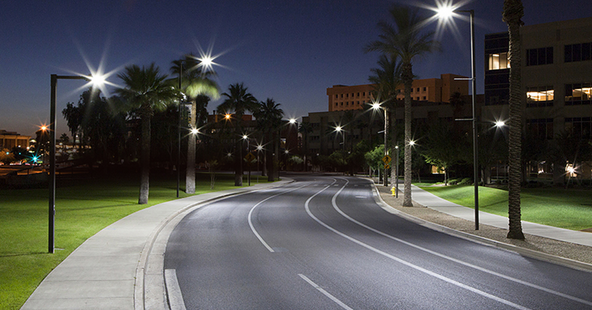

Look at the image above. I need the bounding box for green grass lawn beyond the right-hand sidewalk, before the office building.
[422,186,592,230]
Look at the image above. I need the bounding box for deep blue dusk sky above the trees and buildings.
[0,0,592,136]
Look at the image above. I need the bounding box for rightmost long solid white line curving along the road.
[331,180,592,306]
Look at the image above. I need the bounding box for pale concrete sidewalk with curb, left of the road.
[21,178,293,310]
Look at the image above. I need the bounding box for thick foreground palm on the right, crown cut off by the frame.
[502,0,524,240]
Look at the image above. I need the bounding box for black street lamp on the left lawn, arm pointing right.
[48,74,105,253]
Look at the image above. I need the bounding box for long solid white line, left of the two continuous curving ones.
[304,180,529,310]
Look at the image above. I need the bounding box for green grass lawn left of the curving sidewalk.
[0,174,267,309]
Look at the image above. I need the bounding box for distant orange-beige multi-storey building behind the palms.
[327,74,469,112]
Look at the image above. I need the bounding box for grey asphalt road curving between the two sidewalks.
[165,176,592,309]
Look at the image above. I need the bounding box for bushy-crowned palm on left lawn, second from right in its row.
[218,83,259,186]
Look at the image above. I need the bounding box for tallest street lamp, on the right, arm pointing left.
[437,5,479,230]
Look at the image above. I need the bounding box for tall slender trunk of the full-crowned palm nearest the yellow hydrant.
[402,63,413,207]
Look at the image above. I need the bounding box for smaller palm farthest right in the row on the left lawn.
[254,98,284,182]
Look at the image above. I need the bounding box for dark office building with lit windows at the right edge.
[481,18,592,182]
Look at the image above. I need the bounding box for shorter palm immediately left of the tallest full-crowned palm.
[368,54,401,186]
